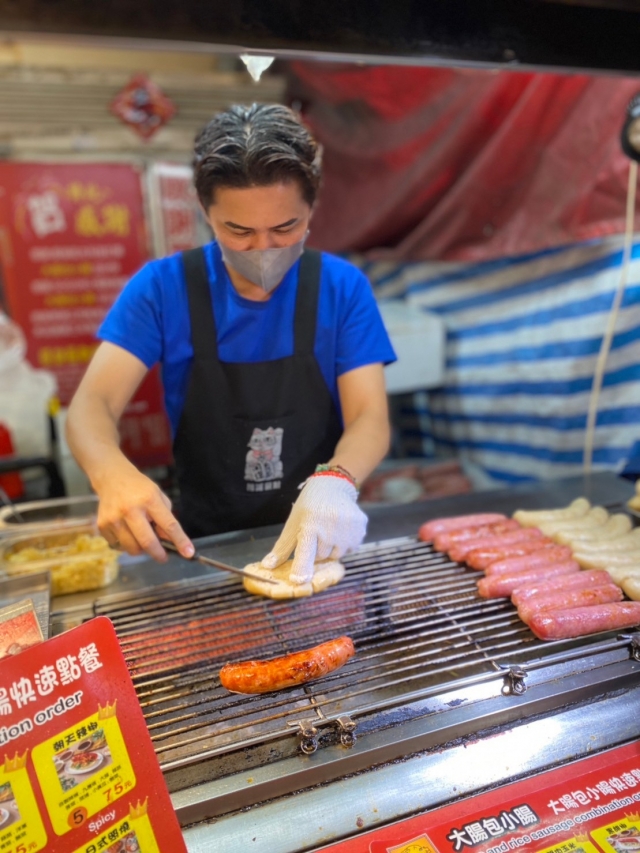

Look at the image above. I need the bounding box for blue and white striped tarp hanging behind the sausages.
[362,237,640,484]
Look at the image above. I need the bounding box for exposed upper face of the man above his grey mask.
[207,181,311,252]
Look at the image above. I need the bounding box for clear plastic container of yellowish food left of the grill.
[0,525,119,595]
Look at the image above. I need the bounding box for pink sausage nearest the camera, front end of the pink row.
[529,601,640,640]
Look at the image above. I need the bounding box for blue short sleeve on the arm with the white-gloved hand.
[336,268,396,376]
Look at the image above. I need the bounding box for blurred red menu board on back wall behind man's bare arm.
[0,162,171,465]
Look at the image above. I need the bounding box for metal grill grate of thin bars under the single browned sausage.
[95,538,608,770]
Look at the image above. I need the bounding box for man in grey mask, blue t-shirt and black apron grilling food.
[67,104,395,583]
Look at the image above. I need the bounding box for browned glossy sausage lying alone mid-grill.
[220,637,356,693]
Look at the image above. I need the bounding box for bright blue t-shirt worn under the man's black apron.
[98,242,396,436]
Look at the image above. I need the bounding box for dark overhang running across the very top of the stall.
[0,0,640,73]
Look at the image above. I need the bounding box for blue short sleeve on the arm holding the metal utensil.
[97,261,163,369]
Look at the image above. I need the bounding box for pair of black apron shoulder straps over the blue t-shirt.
[182,247,322,360]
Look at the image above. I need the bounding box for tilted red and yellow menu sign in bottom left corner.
[0,617,186,853]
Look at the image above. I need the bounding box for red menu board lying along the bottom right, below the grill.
[322,741,640,853]
